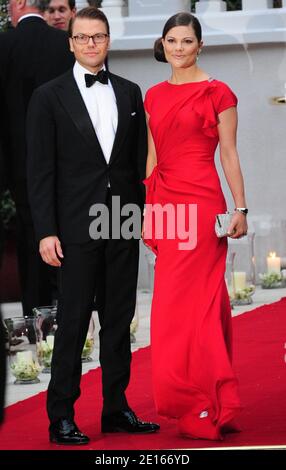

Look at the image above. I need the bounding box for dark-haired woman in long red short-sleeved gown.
[143,13,247,439]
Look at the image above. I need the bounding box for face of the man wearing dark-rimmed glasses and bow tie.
[70,18,110,73]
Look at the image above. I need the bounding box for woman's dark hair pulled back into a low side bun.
[154,12,202,62]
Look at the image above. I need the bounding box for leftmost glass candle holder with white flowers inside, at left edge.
[5,317,42,385]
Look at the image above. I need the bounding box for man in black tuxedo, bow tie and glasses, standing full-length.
[27,7,159,444]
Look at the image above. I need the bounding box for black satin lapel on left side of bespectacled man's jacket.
[54,70,106,164]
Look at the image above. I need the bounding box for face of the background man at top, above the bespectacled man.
[45,0,76,31]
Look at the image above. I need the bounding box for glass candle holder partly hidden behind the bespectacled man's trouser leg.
[33,306,57,374]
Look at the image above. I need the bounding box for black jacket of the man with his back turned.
[0,16,74,203]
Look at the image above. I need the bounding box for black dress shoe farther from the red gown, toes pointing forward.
[49,418,89,445]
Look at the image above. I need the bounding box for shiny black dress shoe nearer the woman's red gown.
[101,410,160,434]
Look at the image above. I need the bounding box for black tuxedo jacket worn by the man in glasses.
[27,70,147,243]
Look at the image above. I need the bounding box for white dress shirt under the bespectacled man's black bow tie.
[73,62,118,163]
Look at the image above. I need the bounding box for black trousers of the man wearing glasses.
[47,192,139,422]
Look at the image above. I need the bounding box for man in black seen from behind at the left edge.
[0,0,74,315]
